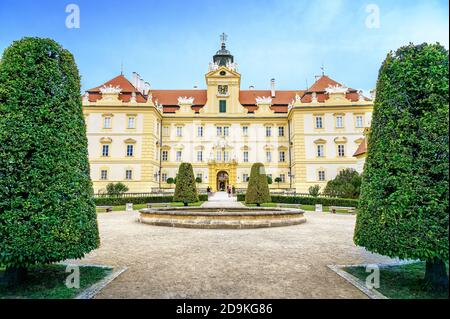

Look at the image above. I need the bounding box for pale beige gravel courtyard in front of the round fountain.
[68,212,392,298]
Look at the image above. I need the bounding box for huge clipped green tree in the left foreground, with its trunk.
[0,38,99,284]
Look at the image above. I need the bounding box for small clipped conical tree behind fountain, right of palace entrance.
[245,163,272,206]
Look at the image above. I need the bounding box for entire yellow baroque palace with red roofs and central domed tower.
[83,37,373,192]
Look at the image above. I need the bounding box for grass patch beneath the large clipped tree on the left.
[0,264,112,299]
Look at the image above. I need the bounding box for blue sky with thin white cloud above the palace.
[0,0,449,91]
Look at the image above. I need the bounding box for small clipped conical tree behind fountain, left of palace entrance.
[173,163,198,206]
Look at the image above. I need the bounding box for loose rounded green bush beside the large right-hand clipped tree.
[323,168,361,198]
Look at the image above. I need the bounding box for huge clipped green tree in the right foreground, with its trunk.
[354,44,449,290]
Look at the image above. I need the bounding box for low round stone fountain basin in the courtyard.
[139,207,306,229]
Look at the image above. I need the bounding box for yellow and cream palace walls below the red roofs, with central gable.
[83,67,373,193]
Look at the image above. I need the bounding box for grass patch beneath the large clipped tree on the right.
[344,262,448,299]
